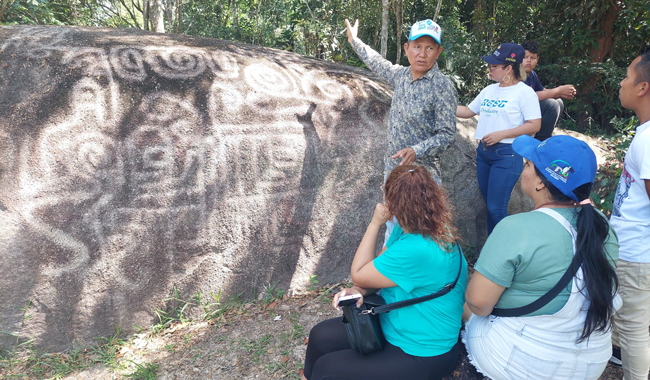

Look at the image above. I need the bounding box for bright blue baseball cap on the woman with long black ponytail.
[512,135,598,202]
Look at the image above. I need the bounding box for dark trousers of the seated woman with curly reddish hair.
[304,318,460,380]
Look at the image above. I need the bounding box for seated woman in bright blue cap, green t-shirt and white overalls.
[463,136,621,379]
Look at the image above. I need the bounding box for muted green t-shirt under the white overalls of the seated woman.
[474,208,618,315]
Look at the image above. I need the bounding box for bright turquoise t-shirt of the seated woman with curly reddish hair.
[374,225,467,356]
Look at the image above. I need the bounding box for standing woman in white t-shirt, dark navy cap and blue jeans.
[456,43,542,234]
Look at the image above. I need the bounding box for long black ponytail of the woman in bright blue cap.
[535,168,618,342]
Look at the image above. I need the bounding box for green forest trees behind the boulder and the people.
[0,0,650,212]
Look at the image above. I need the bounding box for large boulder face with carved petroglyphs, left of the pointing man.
[0,27,390,349]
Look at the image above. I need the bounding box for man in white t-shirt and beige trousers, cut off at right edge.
[610,46,650,380]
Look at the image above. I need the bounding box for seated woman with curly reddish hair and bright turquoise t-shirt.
[304,165,467,380]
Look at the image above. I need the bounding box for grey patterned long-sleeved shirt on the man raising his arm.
[352,38,458,178]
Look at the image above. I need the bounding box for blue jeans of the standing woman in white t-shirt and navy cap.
[476,143,524,235]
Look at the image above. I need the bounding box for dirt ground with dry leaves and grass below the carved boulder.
[0,283,623,380]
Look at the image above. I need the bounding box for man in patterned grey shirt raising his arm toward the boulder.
[345,20,458,181]
